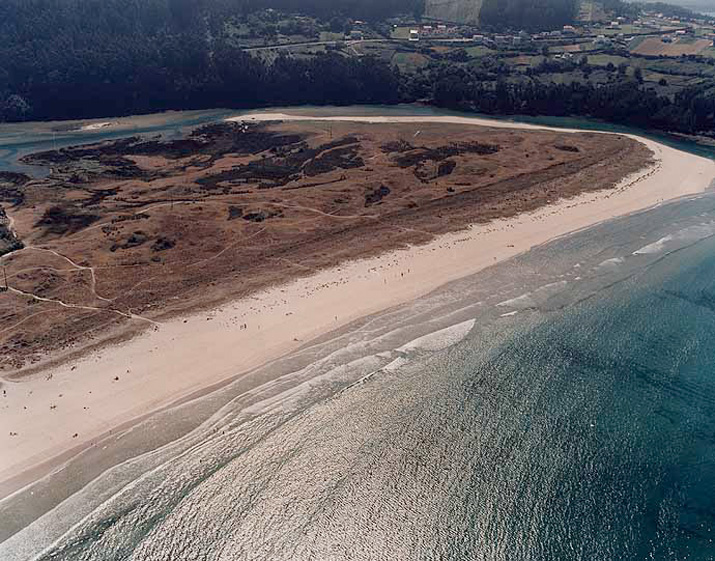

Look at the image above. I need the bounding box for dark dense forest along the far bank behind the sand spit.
[0,0,715,133]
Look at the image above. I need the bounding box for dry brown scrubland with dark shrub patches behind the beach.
[0,123,651,371]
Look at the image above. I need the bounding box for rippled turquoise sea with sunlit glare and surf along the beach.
[0,107,715,561]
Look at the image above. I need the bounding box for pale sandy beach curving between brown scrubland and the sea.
[0,114,715,497]
